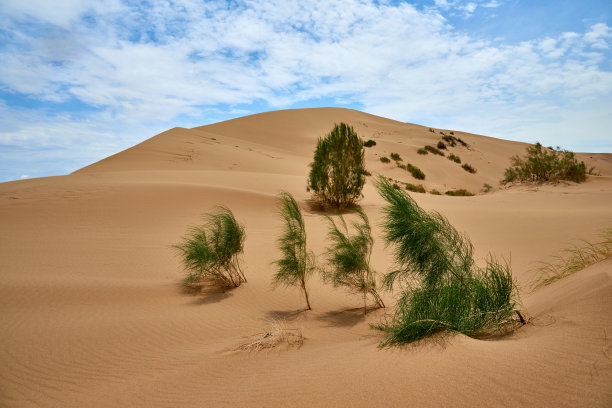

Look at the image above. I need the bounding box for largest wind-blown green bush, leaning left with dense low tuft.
[374,178,515,346]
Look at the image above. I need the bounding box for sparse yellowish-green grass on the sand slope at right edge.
[532,228,612,290]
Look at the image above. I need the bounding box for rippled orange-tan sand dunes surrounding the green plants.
[0,108,612,407]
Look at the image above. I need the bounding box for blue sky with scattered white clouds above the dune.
[0,0,612,181]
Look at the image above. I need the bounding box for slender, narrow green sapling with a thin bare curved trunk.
[273,192,315,310]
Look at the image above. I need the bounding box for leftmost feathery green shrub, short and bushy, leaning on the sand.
[173,207,247,289]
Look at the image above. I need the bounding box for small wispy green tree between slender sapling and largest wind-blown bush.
[322,210,385,314]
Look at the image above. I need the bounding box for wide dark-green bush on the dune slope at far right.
[501,143,586,184]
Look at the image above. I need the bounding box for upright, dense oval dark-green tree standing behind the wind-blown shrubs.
[307,123,365,208]
